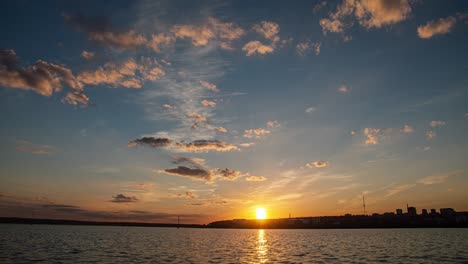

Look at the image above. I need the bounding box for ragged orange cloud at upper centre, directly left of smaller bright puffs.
[171,17,245,50]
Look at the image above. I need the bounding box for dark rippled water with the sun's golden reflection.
[0,224,468,263]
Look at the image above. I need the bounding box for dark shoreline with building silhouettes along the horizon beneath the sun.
[0,207,468,229]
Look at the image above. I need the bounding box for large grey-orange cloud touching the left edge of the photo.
[0,49,83,96]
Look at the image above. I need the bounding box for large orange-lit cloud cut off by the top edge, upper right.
[320,0,411,33]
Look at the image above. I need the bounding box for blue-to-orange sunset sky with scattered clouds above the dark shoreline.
[0,0,468,224]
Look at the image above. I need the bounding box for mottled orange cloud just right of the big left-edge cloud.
[77,58,165,89]
